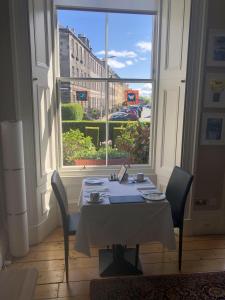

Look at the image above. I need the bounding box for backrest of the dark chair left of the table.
[51,170,68,231]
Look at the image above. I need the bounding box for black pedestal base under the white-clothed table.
[99,245,143,277]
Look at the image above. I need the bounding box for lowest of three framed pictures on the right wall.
[201,113,225,145]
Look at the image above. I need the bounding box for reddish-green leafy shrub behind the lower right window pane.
[116,122,150,163]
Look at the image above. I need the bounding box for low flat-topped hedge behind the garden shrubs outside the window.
[62,121,150,142]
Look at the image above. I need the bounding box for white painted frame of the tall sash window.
[53,0,160,177]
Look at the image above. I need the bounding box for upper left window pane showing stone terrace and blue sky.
[57,9,105,77]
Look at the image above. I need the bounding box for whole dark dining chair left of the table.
[51,171,80,282]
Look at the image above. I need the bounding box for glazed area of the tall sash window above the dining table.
[58,9,154,167]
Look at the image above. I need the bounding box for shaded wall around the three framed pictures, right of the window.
[192,0,225,234]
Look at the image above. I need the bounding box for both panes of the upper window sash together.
[58,9,154,79]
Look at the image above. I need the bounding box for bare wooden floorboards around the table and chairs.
[10,228,225,300]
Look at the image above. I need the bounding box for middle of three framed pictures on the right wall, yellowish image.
[204,73,225,108]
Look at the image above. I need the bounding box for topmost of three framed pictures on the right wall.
[207,29,225,67]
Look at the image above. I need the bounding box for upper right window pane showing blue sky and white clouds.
[108,13,154,79]
